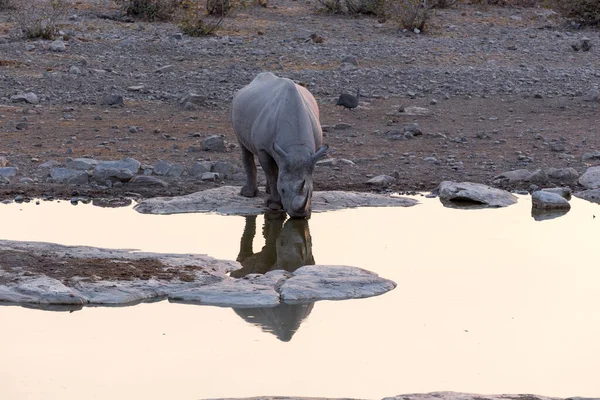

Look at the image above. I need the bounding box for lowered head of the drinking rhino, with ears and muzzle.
[273,143,329,218]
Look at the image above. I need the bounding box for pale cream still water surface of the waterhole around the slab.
[0,197,600,400]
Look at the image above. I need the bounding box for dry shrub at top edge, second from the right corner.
[379,0,436,31]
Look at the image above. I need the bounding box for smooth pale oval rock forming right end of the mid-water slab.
[280,265,396,304]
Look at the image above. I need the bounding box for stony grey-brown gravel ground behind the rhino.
[0,0,600,198]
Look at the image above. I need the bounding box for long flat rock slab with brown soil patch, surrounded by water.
[0,240,396,309]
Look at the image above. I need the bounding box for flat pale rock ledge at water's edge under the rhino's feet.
[134,186,418,215]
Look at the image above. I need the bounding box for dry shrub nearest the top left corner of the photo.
[11,0,71,40]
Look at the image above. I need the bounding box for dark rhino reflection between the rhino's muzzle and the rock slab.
[231,213,315,278]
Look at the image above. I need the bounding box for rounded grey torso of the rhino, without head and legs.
[232,73,322,154]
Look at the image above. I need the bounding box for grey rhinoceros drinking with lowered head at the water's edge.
[231,72,328,218]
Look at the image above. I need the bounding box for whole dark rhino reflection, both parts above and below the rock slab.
[231,213,315,342]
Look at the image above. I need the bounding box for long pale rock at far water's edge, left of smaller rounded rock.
[437,181,517,207]
